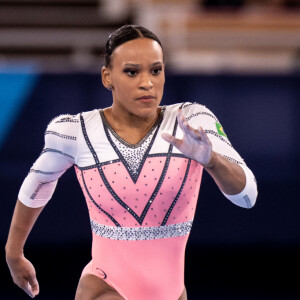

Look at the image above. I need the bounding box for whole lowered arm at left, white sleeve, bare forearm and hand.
[5,115,79,298]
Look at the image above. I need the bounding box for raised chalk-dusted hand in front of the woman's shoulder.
[162,109,212,166]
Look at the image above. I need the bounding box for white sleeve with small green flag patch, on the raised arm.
[182,103,257,208]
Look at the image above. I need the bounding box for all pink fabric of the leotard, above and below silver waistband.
[76,156,203,300]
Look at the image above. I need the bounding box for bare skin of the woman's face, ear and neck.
[102,38,165,144]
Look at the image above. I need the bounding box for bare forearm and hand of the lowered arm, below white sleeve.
[5,199,44,298]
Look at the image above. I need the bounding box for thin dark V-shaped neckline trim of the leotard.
[99,106,165,149]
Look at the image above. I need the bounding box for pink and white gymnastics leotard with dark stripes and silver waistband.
[19,103,257,300]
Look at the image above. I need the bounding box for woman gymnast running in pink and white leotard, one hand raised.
[6,25,257,300]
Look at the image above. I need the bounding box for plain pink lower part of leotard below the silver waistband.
[82,234,188,300]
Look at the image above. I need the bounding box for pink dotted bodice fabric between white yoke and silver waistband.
[76,157,202,227]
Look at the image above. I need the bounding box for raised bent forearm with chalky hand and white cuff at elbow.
[162,110,257,208]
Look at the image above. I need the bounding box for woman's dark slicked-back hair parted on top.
[104,25,163,67]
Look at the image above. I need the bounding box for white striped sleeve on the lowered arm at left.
[18,115,79,207]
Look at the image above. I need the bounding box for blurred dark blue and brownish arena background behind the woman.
[0,0,300,300]
